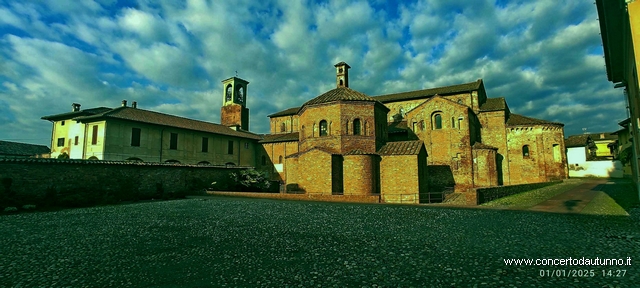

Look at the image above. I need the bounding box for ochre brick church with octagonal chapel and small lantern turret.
[258,62,567,203]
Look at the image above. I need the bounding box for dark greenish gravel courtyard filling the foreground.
[0,197,640,287]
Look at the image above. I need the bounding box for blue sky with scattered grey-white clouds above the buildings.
[0,0,627,146]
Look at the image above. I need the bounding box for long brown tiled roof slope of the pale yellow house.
[74,107,261,140]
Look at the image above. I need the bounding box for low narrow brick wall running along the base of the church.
[207,191,380,203]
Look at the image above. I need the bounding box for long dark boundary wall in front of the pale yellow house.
[0,159,246,204]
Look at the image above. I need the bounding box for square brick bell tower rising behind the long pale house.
[220,77,249,131]
